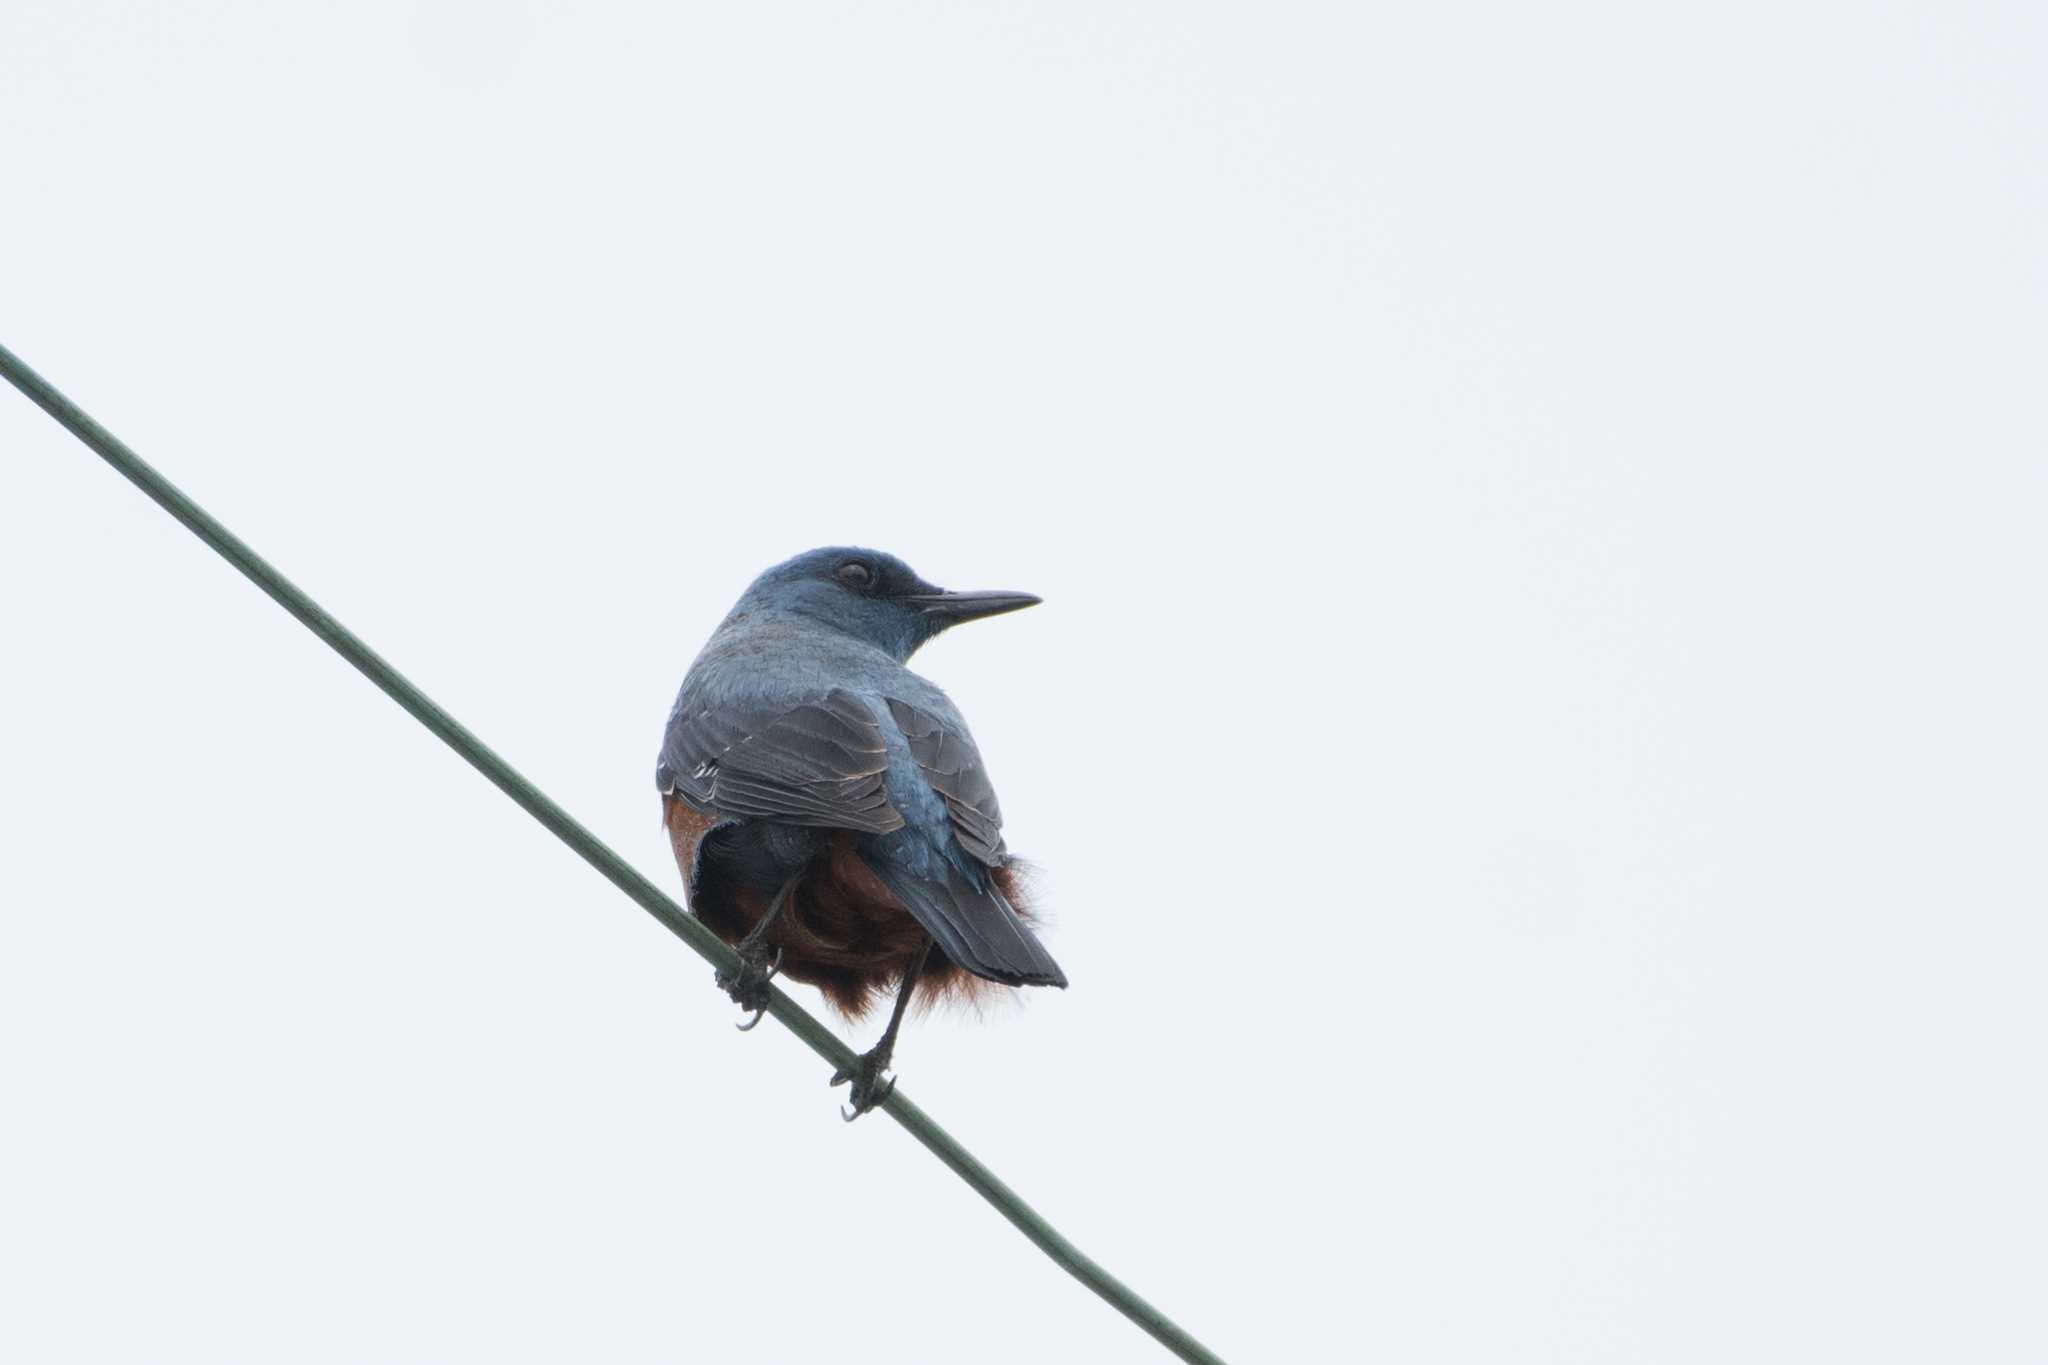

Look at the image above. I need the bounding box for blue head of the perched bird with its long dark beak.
[735,544,1038,663]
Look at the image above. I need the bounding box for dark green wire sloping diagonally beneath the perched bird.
[0,346,1223,1365]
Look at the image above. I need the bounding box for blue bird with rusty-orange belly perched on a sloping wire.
[655,546,1067,1121]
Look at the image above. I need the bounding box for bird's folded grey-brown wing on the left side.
[655,688,903,835]
